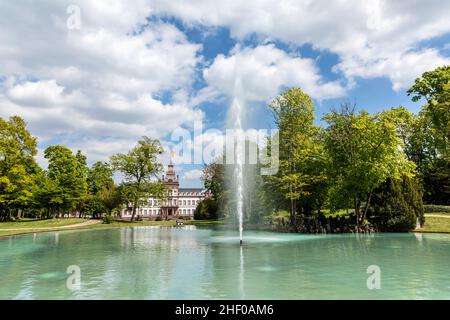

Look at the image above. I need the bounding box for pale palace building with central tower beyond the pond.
[122,162,209,218]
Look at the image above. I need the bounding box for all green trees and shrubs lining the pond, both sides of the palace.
[0,66,450,233]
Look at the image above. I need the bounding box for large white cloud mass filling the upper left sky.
[0,0,203,164]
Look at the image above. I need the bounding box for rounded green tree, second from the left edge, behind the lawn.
[44,146,87,216]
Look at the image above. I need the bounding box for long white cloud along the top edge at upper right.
[153,0,450,90]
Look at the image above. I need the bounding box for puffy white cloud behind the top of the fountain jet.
[204,44,345,101]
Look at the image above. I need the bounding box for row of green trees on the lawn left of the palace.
[0,116,164,221]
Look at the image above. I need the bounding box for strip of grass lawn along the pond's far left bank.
[0,218,223,236]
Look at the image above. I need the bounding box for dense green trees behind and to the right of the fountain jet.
[204,66,450,230]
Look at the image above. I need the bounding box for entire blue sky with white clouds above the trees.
[0,0,450,187]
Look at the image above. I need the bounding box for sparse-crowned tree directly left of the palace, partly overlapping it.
[111,137,164,221]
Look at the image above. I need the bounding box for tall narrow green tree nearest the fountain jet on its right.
[266,89,325,225]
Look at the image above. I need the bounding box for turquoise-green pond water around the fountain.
[0,226,450,299]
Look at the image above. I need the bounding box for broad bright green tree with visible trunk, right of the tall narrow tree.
[324,105,414,227]
